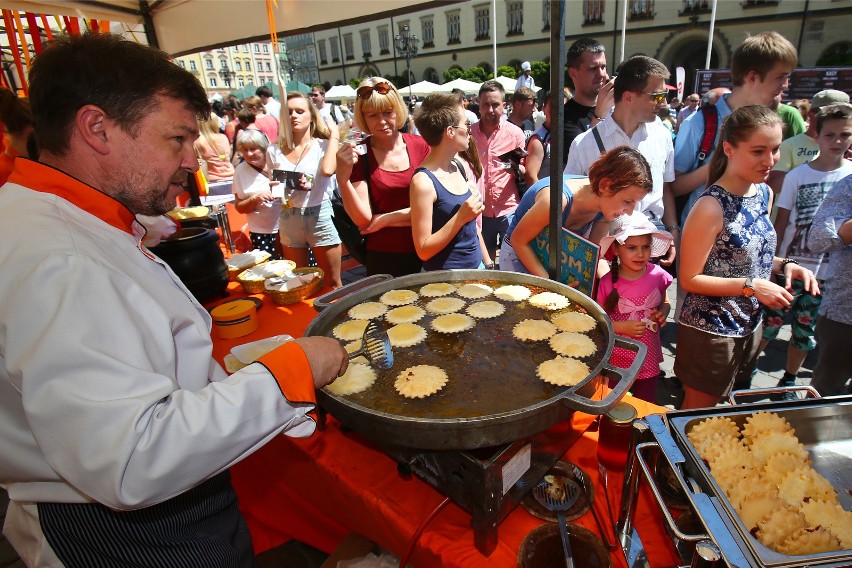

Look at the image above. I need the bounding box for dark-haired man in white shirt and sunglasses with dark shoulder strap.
[565,55,677,265]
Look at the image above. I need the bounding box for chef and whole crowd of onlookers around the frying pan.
[0,32,852,565]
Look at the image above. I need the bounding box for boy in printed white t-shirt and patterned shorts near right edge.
[761,103,852,398]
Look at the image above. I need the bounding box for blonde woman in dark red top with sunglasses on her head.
[337,77,429,276]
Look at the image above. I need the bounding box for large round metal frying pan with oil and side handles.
[305,270,646,450]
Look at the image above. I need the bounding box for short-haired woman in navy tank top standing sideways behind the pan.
[410,93,484,270]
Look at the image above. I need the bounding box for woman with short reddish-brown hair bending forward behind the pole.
[500,146,653,278]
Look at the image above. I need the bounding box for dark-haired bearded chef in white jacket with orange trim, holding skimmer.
[0,35,347,567]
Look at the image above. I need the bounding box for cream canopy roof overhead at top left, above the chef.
[3,0,434,55]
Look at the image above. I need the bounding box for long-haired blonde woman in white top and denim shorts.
[267,92,342,288]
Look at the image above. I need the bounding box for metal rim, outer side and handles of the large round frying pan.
[305,270,646,450]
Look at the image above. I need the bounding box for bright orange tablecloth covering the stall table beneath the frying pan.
[214,285,678,567]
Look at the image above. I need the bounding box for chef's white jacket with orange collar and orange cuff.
[0,158,316,565]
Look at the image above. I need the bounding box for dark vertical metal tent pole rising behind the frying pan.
[547,0,565,280]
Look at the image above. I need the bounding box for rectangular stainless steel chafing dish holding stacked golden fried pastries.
[618,389,852,568]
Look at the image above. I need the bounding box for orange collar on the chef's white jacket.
[9,158,136,234]
